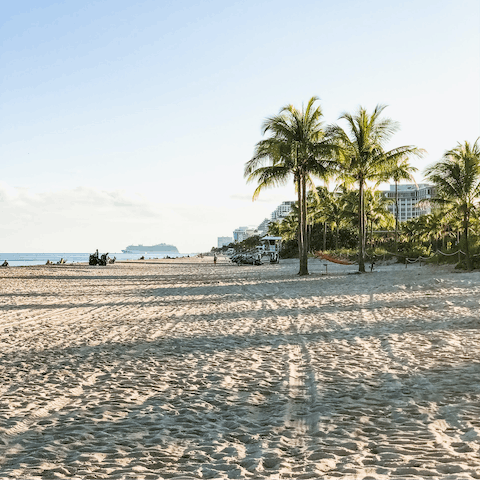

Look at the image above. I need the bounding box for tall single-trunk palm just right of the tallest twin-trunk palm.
[328,105,422,272]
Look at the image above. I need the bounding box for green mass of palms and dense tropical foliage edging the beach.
[245,97,480,275]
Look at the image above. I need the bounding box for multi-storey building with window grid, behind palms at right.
[382,183,434,222]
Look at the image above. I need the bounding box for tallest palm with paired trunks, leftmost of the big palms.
[245,97,335,275]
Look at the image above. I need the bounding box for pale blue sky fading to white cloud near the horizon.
[0,0,480,253]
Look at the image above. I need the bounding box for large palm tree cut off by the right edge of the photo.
[425,138,480,270]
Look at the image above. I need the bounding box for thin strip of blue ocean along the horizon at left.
[0,252,197,267]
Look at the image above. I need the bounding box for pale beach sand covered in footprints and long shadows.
[0,258,480,480]
